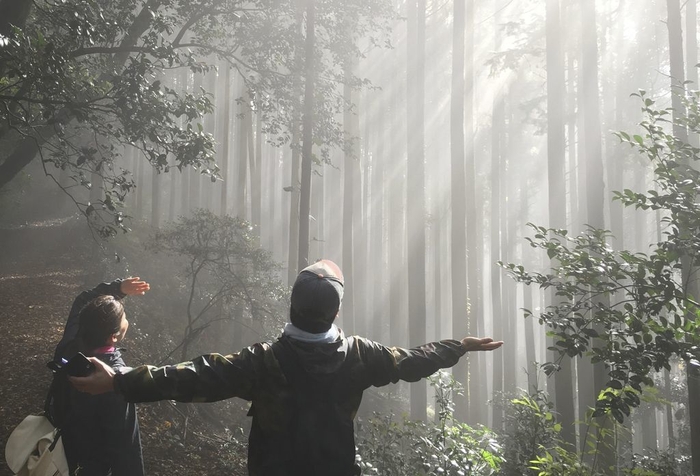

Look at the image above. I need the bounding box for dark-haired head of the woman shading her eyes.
[78,295,124,352]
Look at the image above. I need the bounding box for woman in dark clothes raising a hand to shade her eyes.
[52,277,150,476]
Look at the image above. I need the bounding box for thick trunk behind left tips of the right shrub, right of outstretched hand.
[546,0,576,447]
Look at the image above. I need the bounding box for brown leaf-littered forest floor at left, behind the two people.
[0,212,246,476]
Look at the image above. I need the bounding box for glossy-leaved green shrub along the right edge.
[502,92,700,422]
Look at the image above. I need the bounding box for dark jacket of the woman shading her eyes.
[54,280,144,476]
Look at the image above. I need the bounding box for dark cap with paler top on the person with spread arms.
[289,259,343,334]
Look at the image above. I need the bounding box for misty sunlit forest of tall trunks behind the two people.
[0,0,700,472]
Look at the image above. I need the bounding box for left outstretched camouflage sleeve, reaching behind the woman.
[114,344,267,403]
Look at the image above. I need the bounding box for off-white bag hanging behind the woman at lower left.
[5,415,69,476]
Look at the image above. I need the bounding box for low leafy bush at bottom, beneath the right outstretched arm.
[358,371,502,476]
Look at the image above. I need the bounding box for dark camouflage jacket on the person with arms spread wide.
[114,333,464,476]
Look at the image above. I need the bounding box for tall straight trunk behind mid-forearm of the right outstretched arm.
[406,0,428,420]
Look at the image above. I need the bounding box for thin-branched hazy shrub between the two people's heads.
[149,210,288,358]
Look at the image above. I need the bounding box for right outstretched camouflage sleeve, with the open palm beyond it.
[355,337,465,387]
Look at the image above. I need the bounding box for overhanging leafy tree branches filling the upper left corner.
[0,0,393,236]
